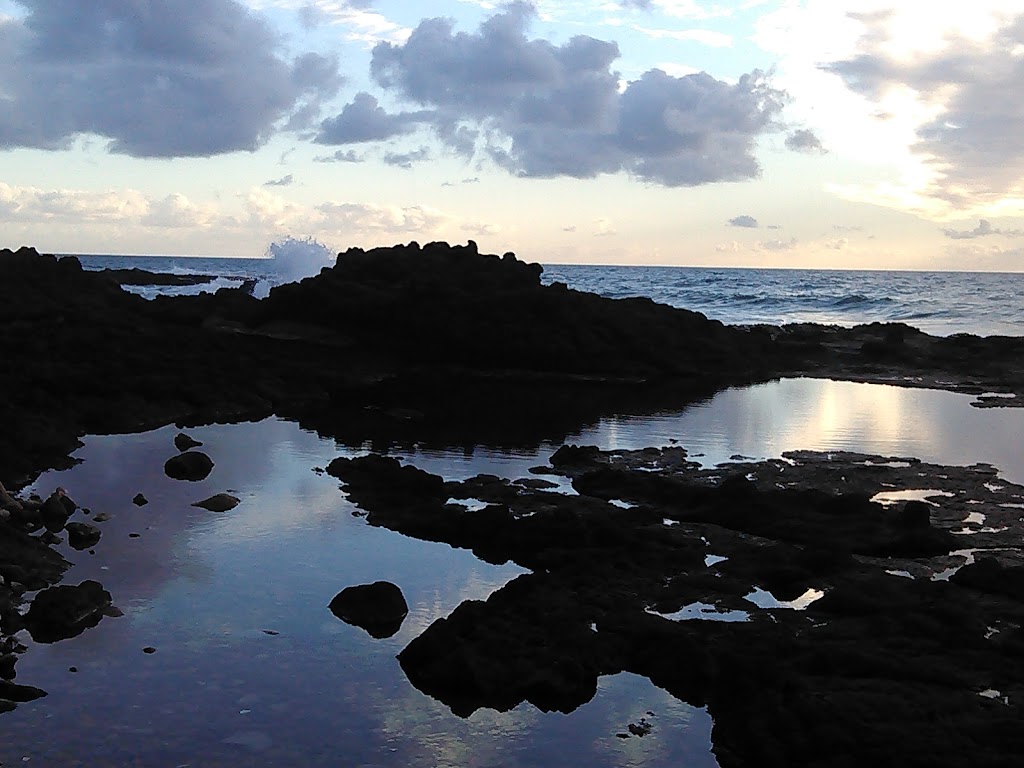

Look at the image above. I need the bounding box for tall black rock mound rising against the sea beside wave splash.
[240,242,764,379]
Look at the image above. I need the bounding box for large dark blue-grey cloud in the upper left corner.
[0,0,342,157]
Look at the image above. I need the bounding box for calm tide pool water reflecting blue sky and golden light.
[6,380,1024,766]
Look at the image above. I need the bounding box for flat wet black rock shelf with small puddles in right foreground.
[329,447,1024,766]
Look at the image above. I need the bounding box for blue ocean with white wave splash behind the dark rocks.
[68,240,1024,336]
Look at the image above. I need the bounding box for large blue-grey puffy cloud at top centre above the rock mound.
[352,2,784,186]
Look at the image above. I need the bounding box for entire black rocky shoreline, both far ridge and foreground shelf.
[0,243,1024,766]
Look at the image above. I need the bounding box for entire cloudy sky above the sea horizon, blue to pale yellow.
[0,0,1024,271]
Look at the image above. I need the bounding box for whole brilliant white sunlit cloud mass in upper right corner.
[756,0,1024,220]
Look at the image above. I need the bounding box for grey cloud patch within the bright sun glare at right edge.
[827,12,1024,208]
